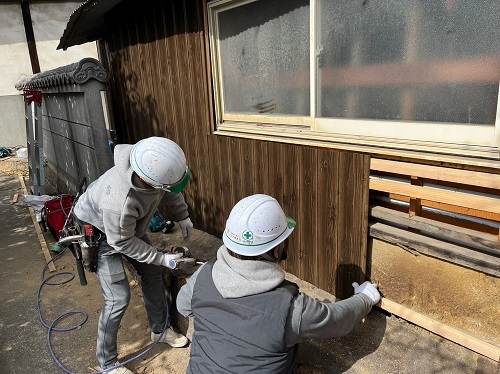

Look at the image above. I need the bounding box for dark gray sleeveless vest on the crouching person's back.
[187,259,299,374]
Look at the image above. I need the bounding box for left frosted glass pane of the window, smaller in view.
[219,0,310,115]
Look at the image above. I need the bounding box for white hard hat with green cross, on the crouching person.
[222,194,296,256]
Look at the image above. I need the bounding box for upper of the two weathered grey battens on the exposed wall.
[370,206,500,257]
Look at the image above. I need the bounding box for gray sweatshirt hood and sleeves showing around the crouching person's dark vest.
[176,245,373,347]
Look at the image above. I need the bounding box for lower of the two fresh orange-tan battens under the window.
[370,178,500,217]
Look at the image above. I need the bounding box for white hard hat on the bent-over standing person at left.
[130,136,191,193]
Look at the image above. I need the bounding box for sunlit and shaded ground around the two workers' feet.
[0,171,500,374]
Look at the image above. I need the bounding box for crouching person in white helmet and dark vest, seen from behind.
[177,194,380,374]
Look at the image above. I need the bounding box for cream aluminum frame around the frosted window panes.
[208,0,500,160]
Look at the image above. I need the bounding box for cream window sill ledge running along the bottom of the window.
[214,121,500,170]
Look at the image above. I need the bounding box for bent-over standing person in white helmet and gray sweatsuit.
[74,137,193,374]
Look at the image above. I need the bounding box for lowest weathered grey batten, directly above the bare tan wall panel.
[369,222,500,277]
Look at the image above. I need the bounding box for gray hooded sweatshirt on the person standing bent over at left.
[74,144,189,265]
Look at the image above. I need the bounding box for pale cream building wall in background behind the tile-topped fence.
[0,1,97,146]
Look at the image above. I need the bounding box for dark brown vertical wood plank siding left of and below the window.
[105,0,369,298]
